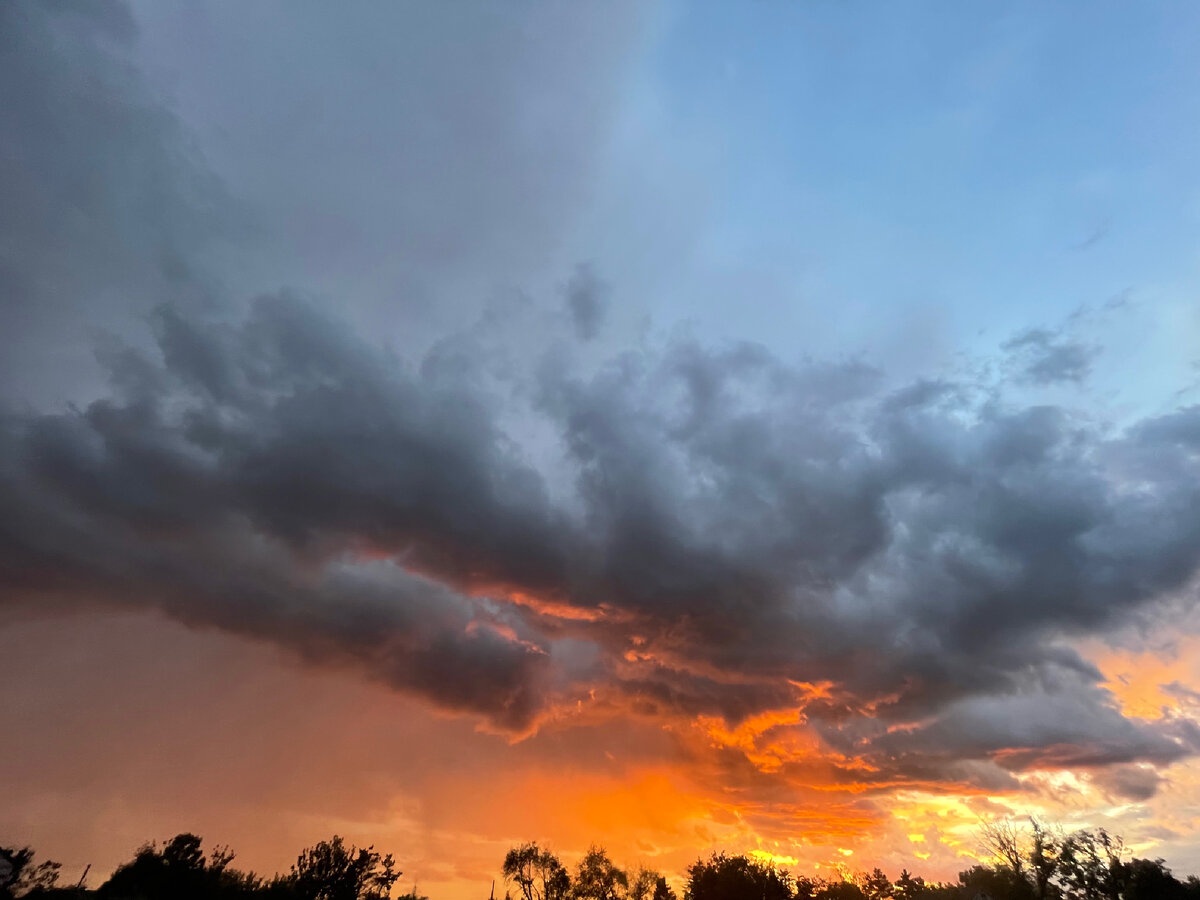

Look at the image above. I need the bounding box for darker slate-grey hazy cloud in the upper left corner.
[0,1,239,402]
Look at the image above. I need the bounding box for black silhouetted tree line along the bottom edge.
[7,820,1200,900]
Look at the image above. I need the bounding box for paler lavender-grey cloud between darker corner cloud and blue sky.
[124,0,654,360]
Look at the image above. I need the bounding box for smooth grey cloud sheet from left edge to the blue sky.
[0,0,650,403]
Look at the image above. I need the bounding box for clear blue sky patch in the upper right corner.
[628,2,1200,393]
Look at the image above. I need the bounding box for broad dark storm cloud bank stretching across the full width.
[7,5,1200,784]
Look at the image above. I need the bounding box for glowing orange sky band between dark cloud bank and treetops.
[7,613,1200,900]
